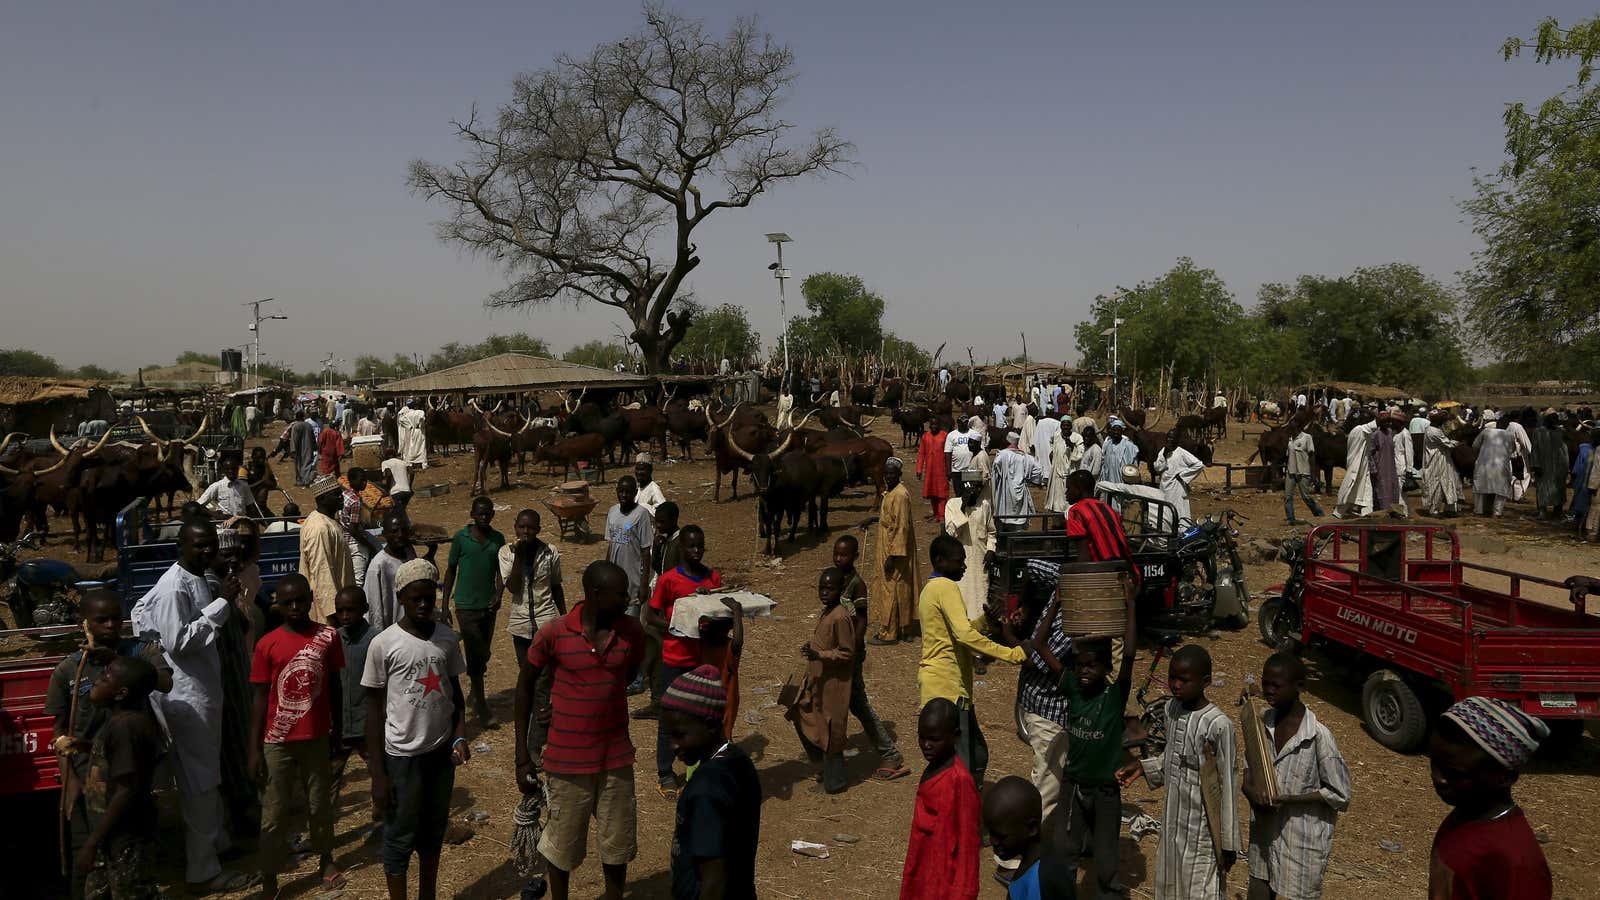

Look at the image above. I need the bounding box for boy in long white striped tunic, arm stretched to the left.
[1118,644,1240,900]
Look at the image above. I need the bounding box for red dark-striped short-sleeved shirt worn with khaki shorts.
[528,604,645,775]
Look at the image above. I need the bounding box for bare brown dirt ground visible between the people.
[15,421,1600,900]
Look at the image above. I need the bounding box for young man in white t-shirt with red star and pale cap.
[362,559,472,897]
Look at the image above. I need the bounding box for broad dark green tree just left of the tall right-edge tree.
[1256,263,1467,391]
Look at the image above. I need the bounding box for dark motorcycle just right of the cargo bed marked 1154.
[1171,509,1250,628]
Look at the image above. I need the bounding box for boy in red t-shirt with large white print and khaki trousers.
[248,573,344,897]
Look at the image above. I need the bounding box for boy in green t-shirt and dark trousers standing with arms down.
[442,496,506,729]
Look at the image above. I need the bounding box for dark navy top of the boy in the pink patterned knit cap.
[672,745,762,900]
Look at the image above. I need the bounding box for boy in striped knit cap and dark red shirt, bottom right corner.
[1427,697,1554,900]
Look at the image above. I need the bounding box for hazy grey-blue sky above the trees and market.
[0,0,1594,370]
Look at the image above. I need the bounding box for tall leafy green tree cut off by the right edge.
[1461,18,1600,378]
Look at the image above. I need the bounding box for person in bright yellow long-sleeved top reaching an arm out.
[917,535,1024,785]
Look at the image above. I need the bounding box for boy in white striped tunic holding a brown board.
[1245,653,1350,900]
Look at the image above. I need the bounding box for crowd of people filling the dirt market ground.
[40,386,1561,900]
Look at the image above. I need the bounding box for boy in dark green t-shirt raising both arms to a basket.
[1032,589,1138,900]
